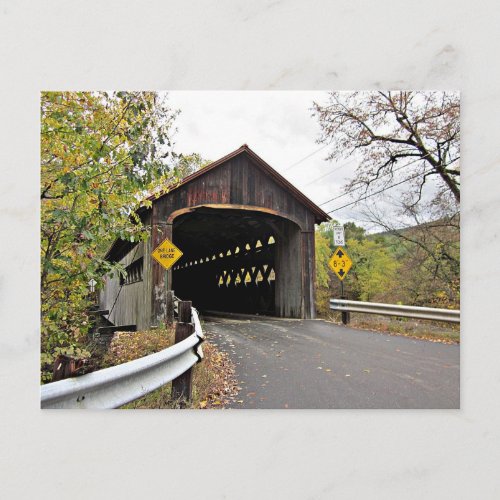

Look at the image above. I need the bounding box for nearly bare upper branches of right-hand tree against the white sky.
[313,91,460,206]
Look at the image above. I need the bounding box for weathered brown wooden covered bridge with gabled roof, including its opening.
[100,144,329,329]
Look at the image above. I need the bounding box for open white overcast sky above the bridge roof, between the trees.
[169,91,366,227]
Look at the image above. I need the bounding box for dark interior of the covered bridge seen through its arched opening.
[172,207,299,315]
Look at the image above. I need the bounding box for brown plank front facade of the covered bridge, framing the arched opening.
[145,154,315,324]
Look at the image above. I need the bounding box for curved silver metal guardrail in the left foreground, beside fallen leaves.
[41,308,204,409]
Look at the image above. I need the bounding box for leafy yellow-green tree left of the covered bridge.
[40,92,177,376]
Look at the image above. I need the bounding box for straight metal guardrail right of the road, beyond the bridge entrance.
[330,299,460,323]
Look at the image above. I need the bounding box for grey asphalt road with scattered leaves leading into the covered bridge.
[204,318,460,408]
